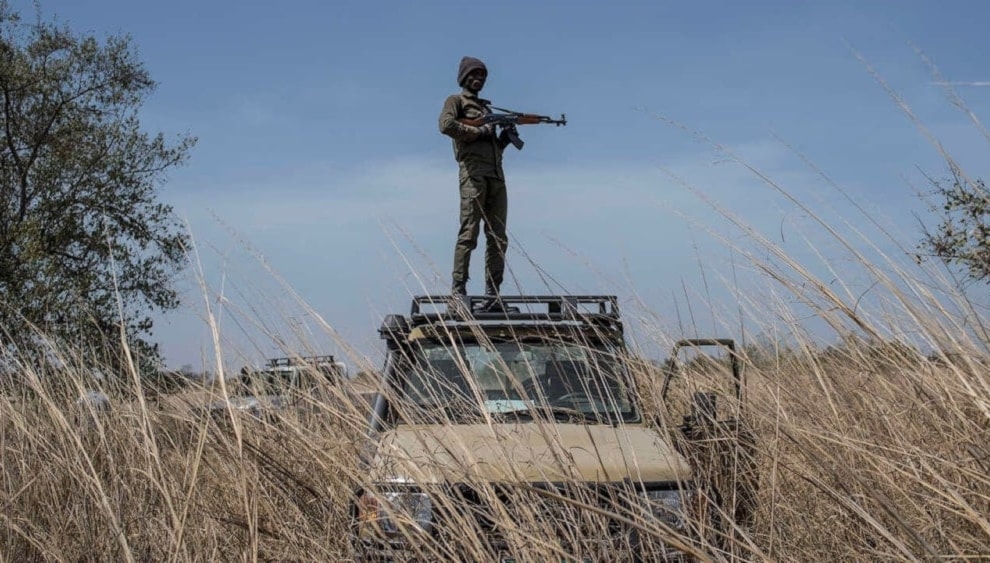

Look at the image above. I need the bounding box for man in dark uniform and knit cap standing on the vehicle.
[440,57,509,307]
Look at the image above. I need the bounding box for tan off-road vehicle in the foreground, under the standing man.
[351,295,744,561]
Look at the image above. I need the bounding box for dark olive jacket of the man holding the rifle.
[440,90,509,178]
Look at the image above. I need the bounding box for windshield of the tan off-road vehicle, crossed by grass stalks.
[405,341,636,422]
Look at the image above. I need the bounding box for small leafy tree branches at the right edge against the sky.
[921,174,990,283]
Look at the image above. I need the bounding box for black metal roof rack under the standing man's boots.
[409,295,619,326]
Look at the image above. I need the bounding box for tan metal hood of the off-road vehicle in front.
[372,422,691,484]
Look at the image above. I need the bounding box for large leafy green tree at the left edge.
[0,0,195,374]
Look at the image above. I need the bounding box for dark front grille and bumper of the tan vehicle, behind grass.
[352,483,690,561]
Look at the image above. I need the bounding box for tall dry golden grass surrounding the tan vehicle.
[0,65,990,561]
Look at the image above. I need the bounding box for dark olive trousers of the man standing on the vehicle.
[452,172,509,289]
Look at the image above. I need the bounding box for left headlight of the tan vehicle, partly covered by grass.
[358,491,433,535]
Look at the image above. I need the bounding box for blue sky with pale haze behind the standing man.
[19,0,990,367]
